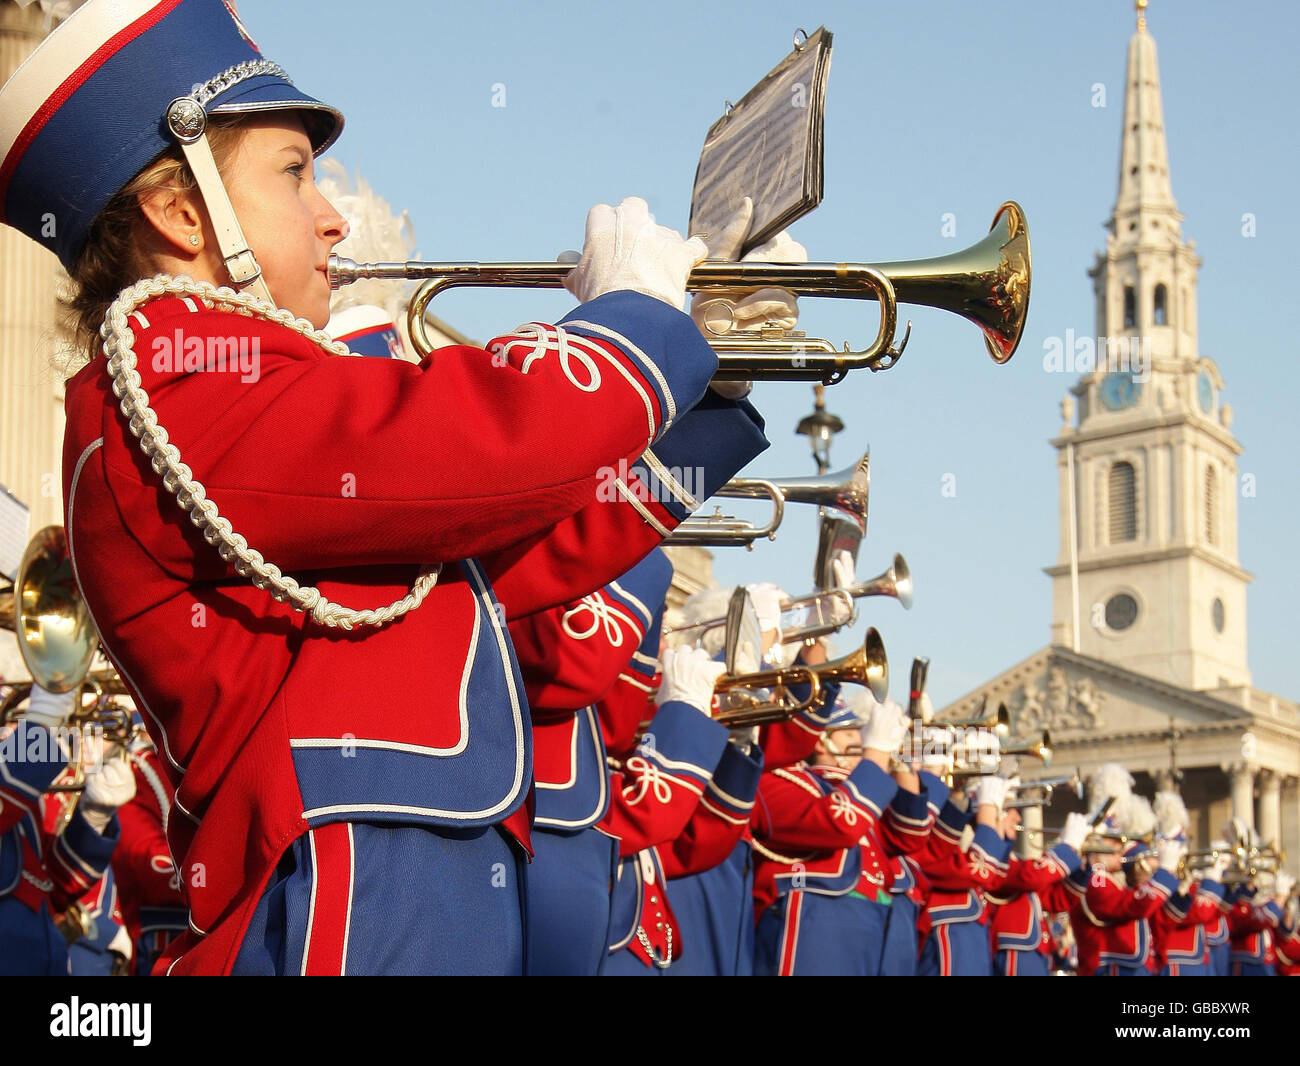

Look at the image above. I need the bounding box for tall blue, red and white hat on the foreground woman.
[0,0,343,273]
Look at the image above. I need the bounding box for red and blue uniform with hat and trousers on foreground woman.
[0,0,764,974]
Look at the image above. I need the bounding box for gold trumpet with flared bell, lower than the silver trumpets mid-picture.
[714,628,889,728]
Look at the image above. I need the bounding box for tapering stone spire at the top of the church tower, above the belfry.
[1110,0,1182,239]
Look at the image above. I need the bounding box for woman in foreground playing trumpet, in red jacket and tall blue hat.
[0,0,766,974]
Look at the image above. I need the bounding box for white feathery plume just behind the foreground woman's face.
[316,159,416,325]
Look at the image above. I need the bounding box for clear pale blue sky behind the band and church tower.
[239,0,1300,705]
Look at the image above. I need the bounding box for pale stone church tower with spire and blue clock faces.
[1047,0,1251,689]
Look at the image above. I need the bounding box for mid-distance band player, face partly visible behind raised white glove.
[753,688,928,976]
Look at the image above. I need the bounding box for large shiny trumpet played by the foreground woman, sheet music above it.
[329,200,1031,385]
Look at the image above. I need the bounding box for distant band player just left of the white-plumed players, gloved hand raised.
[988,810,1088,978]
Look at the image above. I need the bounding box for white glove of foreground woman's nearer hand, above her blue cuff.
[560,196,709,311]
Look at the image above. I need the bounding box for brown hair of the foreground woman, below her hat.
[61,117,248,377]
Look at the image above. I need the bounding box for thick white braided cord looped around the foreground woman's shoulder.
[99,274,442,629]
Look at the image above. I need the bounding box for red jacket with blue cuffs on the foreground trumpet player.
[64,293,761,972]
